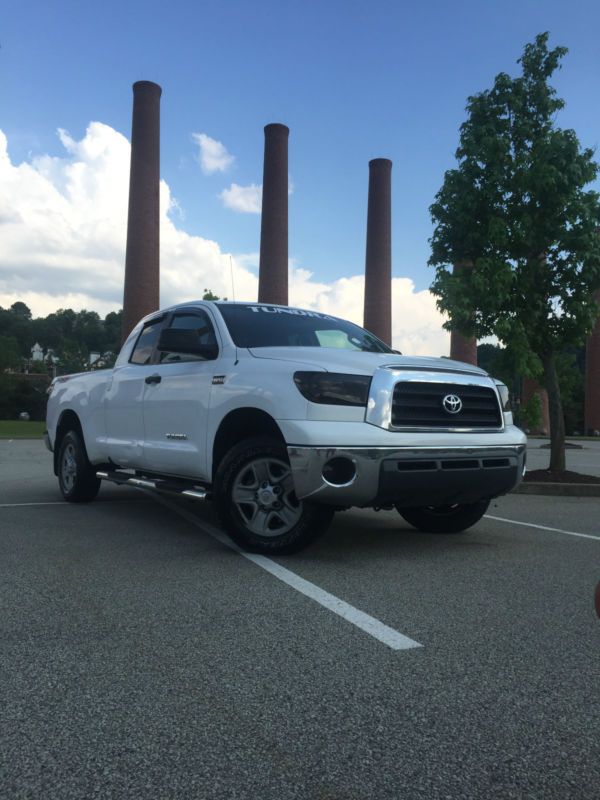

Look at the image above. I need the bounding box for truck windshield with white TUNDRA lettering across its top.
[216,303,394,353]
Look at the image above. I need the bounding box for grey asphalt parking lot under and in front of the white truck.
[0,441,600,800]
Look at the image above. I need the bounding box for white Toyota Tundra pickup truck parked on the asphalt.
[46,301,526,554]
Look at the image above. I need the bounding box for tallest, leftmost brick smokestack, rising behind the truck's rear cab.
[122,81,162,340]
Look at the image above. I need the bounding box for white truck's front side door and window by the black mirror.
[144,308,220,479]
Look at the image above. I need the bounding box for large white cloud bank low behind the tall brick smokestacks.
[0,122,449,355]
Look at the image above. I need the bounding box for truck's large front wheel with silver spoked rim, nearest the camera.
[214,437,334,555]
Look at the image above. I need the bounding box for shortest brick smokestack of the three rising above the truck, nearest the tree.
[364,158,392,345]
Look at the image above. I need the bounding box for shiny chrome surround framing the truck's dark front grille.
[365,366,504,433]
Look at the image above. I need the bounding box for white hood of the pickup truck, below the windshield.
[248,347,487,375]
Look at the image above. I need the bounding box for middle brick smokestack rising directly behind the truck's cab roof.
[258,122,290,306]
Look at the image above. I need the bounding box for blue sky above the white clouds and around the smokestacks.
[0,0,600,350]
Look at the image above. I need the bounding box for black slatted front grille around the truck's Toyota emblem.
[392,381,502,428]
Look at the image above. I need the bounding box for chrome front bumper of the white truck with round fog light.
[288,444,526,508]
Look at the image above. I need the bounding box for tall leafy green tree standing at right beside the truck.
[429,33,600,470]
